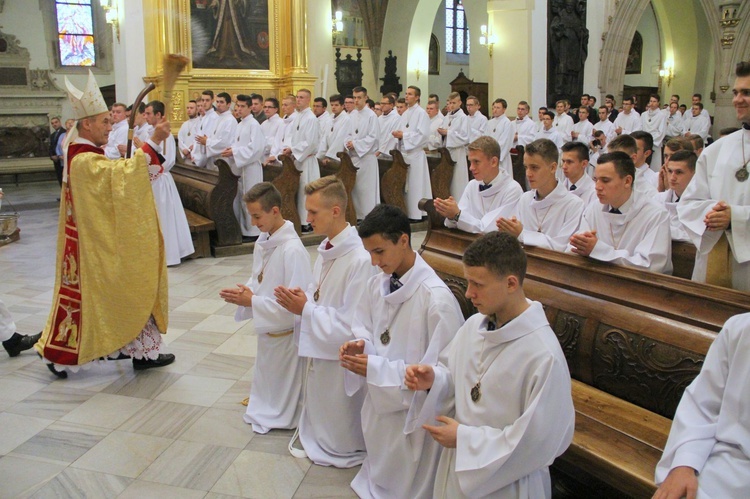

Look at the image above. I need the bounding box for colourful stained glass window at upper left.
[55,0,96,66]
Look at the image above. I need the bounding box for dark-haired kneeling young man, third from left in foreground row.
[340,204,464,498]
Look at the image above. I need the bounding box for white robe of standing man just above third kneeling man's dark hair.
[398,104,432,220]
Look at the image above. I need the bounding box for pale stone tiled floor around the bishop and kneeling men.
[0,183,424,499]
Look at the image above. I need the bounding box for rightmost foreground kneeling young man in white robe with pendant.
[405,232,575,498]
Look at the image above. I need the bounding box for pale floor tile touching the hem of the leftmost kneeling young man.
[180,403,254,449]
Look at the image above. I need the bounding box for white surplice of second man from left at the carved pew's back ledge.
[516,182,585,251]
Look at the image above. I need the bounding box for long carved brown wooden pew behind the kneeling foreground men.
[420,200,750,498]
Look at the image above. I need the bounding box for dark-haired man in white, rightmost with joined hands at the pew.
[566,151,672,274]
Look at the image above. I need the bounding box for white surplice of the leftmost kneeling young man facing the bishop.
[234,221,312,433]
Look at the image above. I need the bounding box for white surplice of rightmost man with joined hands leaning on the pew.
[566,192,672,274]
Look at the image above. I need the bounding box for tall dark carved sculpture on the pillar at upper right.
[547,0,589,103]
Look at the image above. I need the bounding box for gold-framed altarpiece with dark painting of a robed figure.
[143,0,315,124]
